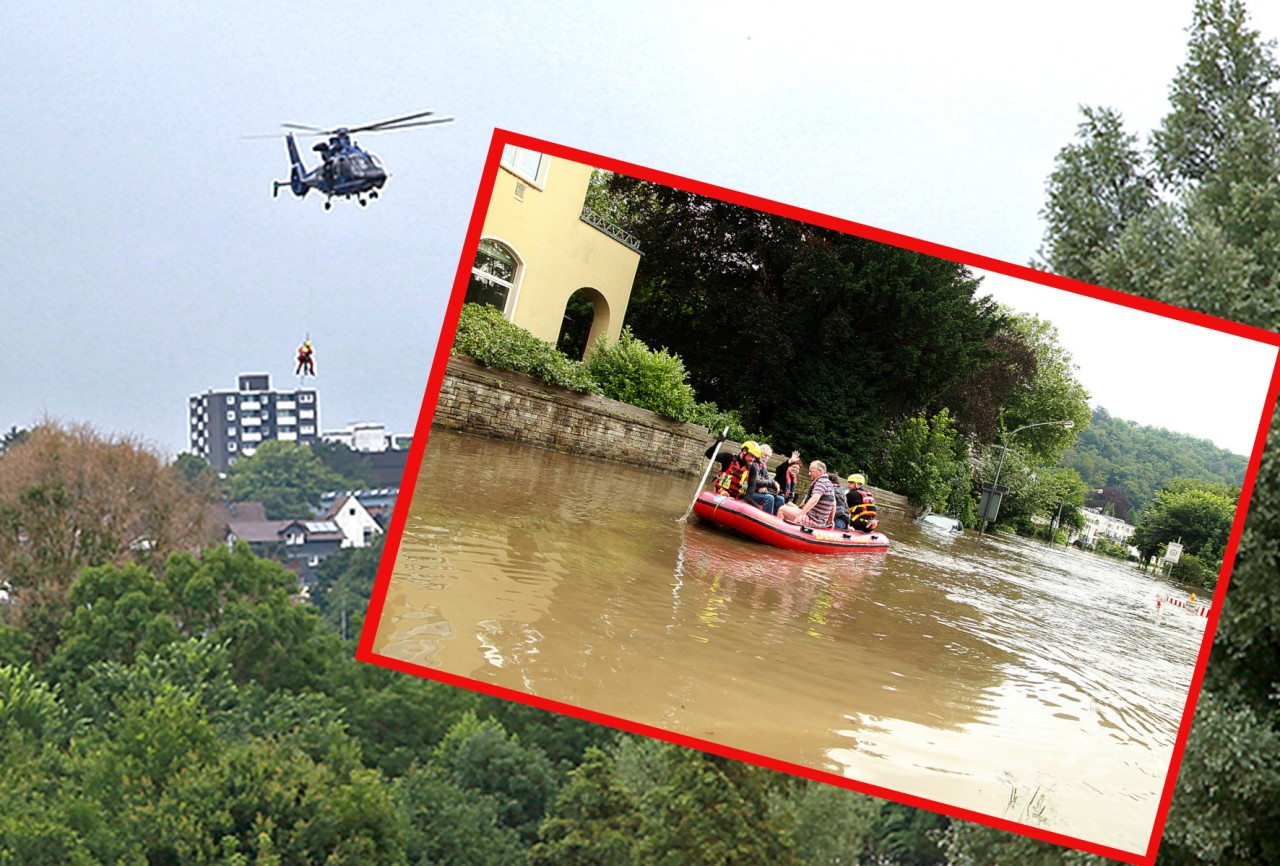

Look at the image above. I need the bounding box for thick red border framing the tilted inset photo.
[356,129,1280,866]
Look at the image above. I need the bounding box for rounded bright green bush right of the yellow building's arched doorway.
[586,327,696,419]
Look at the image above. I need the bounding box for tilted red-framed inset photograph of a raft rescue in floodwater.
[358,130,1280,862]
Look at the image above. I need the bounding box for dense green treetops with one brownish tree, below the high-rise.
[0,423,960,866]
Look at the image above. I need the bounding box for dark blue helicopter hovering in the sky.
[271,111,453,210]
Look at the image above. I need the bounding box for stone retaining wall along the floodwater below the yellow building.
[431,354,915,517]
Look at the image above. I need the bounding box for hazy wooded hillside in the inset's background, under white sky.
[1062,407,1248,523]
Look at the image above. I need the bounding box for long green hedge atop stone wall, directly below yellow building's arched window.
[453,303,600,394]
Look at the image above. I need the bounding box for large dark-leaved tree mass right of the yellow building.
[608,175,1000,463]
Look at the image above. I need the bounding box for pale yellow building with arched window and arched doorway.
[466,145,640,345]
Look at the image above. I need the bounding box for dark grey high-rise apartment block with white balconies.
[187,374,320,471]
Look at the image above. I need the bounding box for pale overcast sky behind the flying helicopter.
[0,0,1280,454]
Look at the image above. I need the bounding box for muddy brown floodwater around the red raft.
[374,430,1206,852]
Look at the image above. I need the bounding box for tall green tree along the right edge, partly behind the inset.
[1034,0,1280,863]
